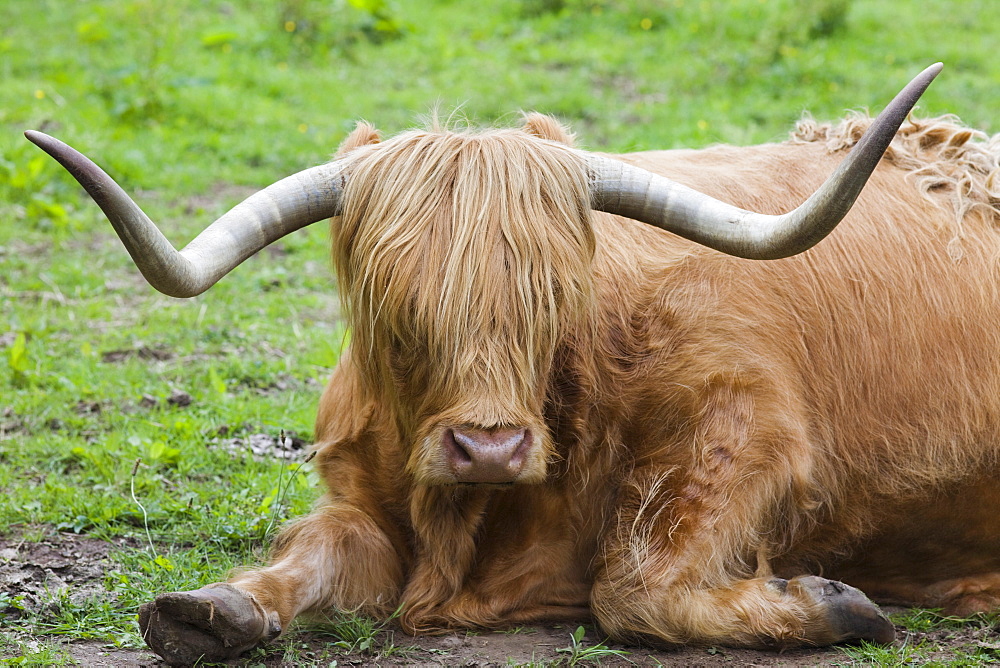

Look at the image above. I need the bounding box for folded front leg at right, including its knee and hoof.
[592,381,894,647]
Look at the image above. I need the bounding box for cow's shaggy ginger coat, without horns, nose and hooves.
[225,115,1000,646]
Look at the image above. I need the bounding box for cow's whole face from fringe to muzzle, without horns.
[333,121,594,484]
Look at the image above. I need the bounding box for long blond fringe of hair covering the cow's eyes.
[333,120,595,412]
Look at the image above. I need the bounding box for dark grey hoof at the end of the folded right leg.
[787,575,896,645]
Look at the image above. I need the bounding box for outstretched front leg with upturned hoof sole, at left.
[139,503,403,664]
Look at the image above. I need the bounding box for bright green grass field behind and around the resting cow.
[0,0,1000,665]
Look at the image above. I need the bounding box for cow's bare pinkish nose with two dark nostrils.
[443,427,531,483]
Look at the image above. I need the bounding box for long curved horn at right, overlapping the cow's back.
[587,63,943,260]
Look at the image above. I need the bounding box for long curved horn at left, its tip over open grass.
[24,130,346,297]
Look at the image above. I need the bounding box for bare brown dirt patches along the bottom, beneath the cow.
[0,534,997,667]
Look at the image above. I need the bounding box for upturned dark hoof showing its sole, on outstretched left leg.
[139,584,281,666]
